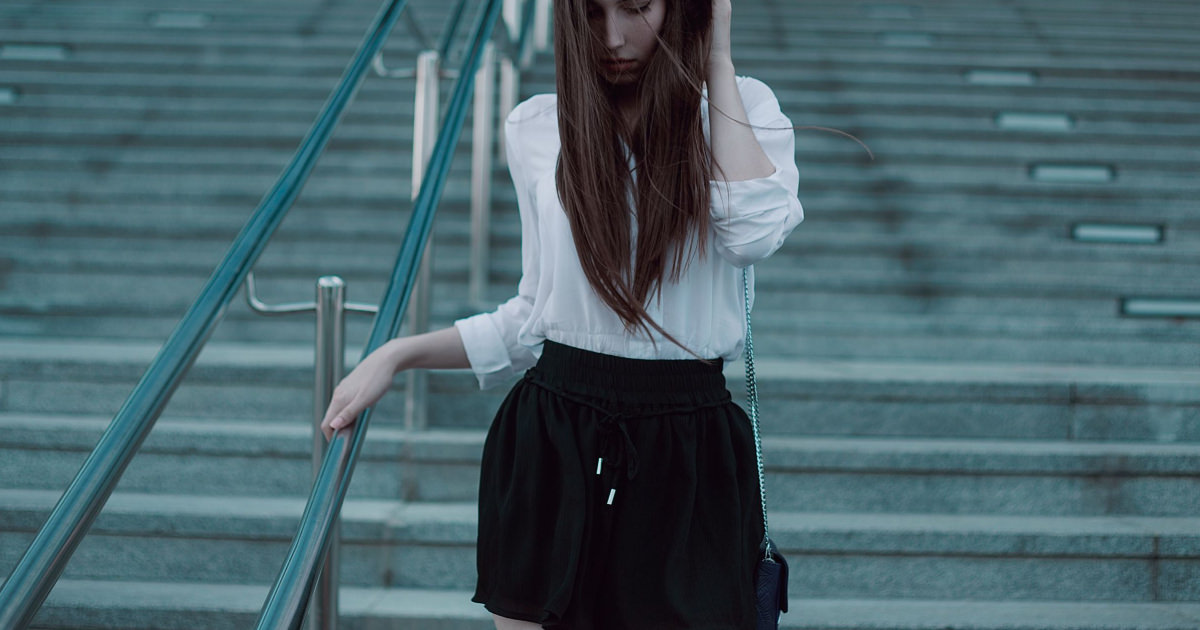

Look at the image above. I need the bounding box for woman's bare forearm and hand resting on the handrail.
[320,326,470,439]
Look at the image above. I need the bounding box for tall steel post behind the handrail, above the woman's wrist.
[404,50,442,430]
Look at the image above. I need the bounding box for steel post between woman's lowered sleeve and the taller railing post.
[467,42,496,306]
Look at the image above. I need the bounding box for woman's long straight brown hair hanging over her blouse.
[554,0,713,345]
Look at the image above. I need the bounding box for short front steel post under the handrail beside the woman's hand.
[305,276,346,630]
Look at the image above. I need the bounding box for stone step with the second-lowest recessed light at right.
[0,196,1200,246]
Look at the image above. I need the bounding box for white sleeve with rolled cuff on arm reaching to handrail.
[455,103,539,389]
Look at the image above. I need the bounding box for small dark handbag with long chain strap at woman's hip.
[742,269,787,630]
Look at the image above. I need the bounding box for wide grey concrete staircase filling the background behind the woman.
[0,0,1200,630]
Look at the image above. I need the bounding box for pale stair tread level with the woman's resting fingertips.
[0,412,1200,465]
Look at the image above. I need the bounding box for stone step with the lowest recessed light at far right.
[0,260,1200,340]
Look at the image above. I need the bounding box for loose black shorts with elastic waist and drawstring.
[473,341,762,630]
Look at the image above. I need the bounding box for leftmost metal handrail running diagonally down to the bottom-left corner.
[0,0,408,630]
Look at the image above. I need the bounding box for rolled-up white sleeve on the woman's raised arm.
[710,79,804,268]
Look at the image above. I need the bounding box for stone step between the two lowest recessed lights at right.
[0,226,1200,283]
